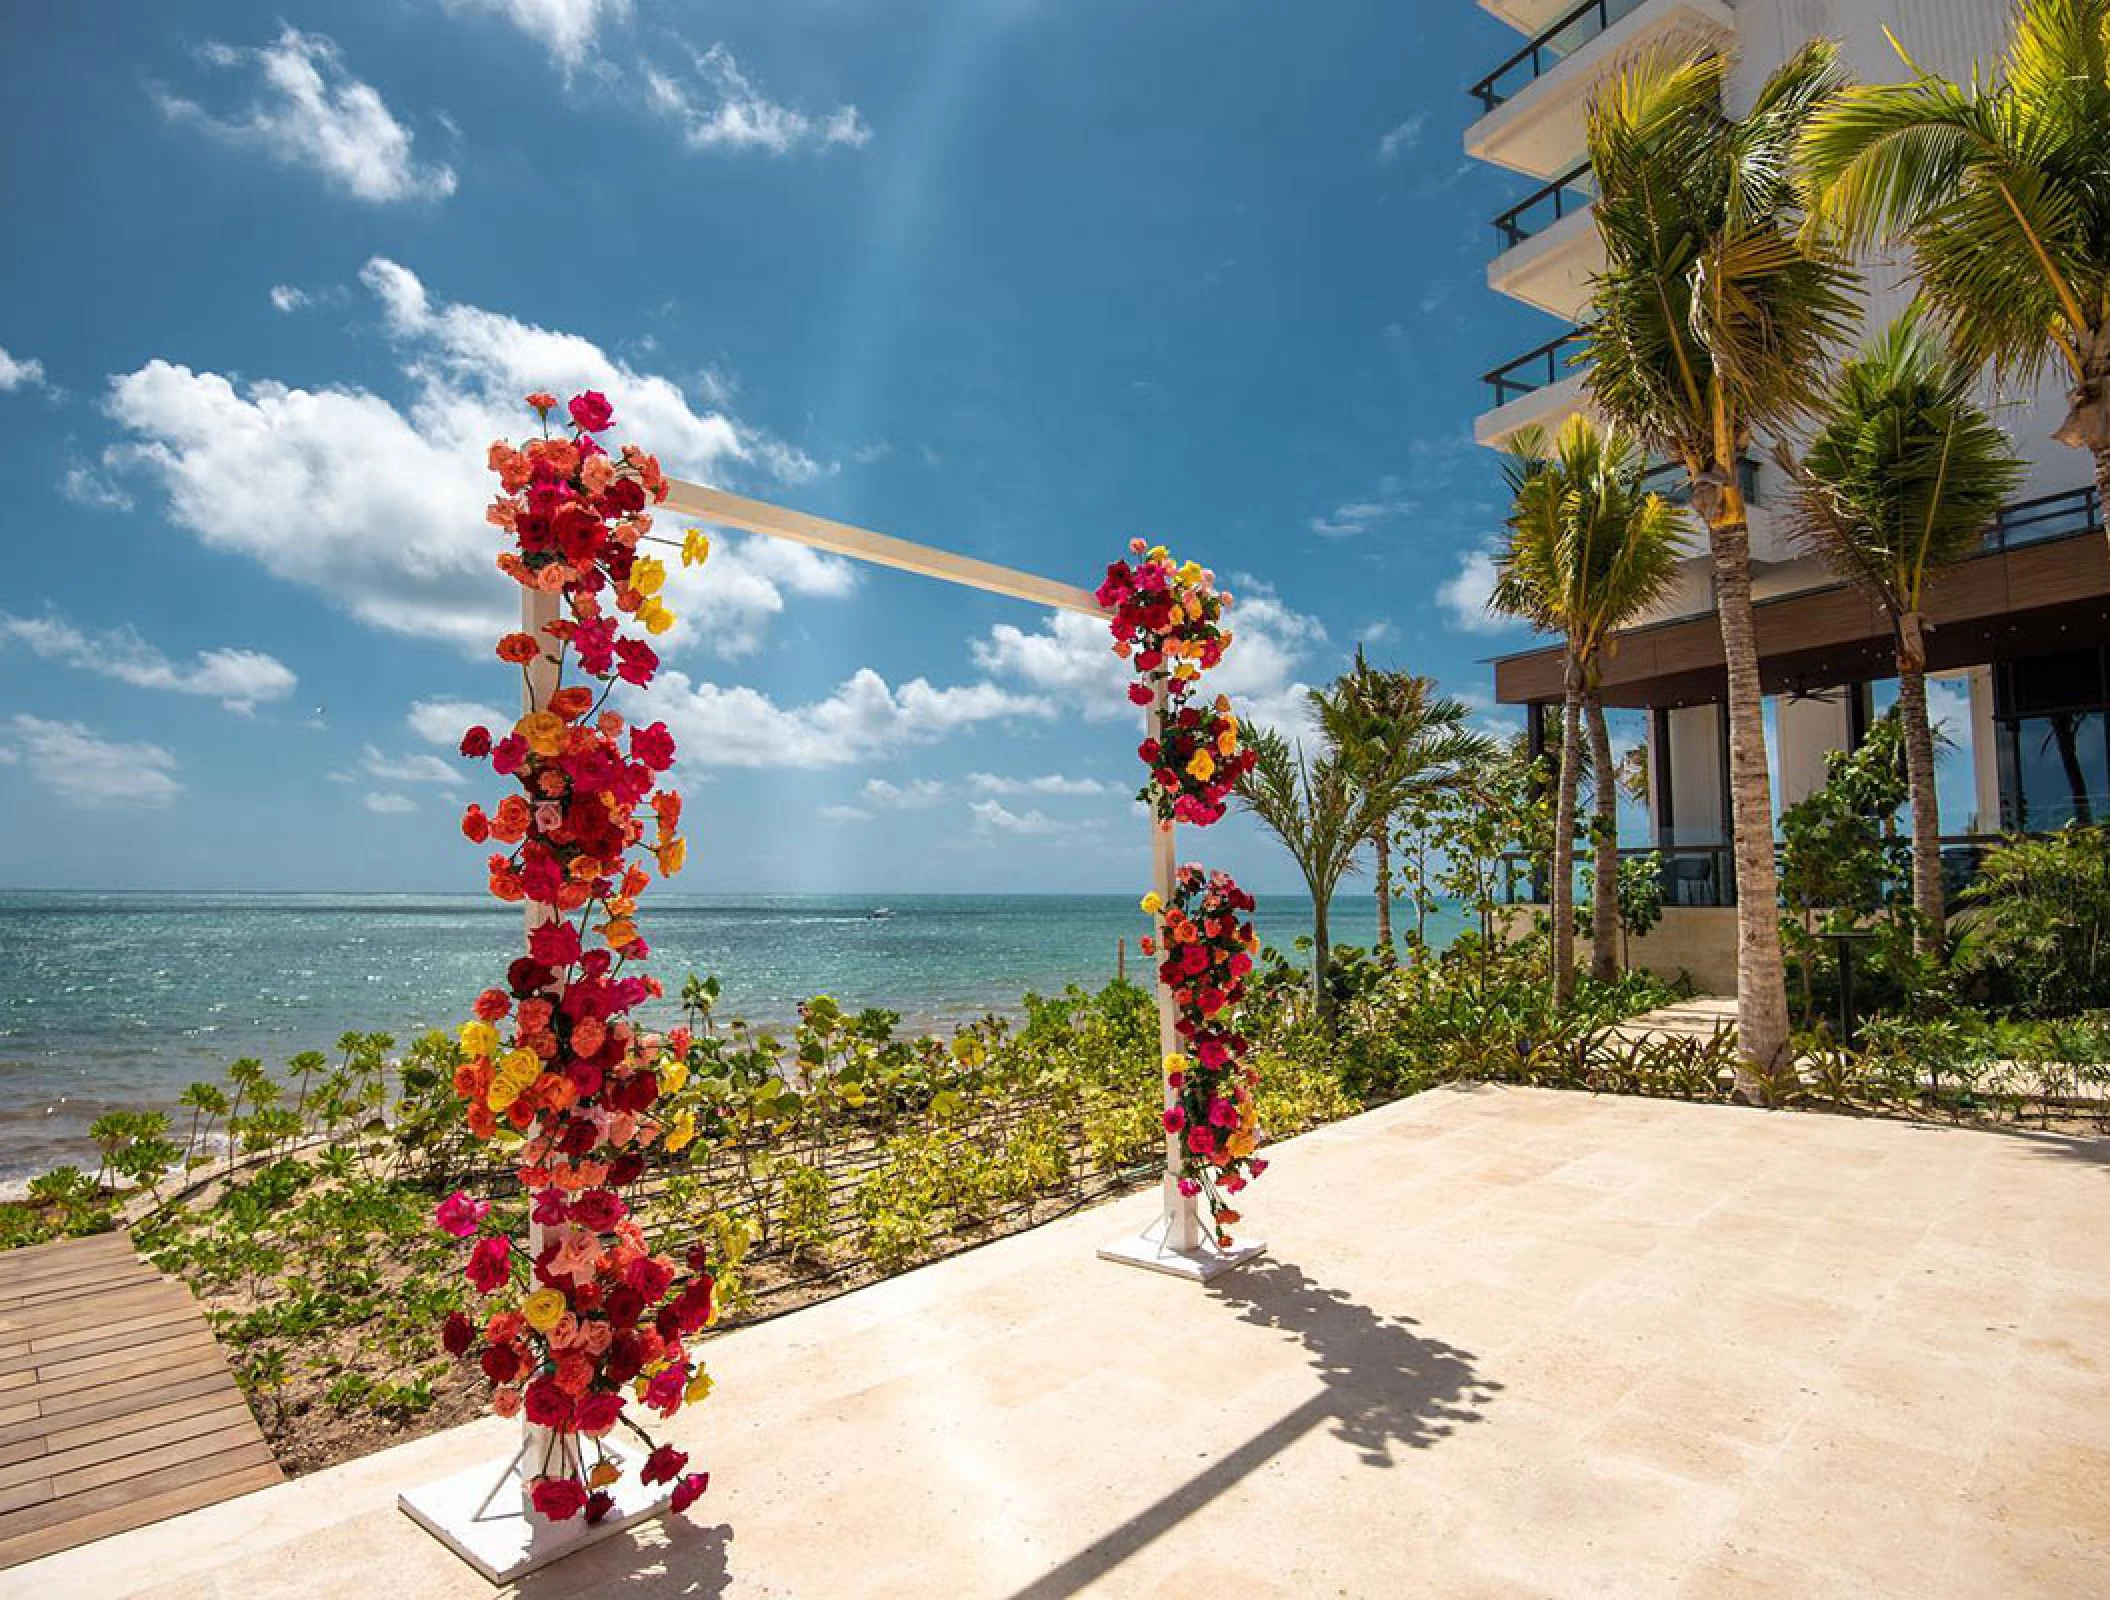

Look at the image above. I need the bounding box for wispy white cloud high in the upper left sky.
[156,27,454,205]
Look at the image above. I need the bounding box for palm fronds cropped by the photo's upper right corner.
[1800,0,2110,538]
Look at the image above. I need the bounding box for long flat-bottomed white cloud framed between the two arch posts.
[625,667,1055,766]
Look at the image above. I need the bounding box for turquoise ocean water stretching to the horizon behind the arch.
[0,891,1460,1180]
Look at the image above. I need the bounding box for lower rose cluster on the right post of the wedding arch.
[1144,865,1268,1247]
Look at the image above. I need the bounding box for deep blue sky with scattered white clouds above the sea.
[0,0,1551,893]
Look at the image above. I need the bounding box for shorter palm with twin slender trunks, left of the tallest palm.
[1492,416,1684,1003]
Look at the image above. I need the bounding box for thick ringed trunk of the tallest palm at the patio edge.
[1694,502,1791,1104]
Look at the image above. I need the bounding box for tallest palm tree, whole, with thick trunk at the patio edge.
[1587,40,1855,1100]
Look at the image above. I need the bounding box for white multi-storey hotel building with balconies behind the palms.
[1464,0,2110,945]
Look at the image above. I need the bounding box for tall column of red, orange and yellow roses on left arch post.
[437,391,715,1520]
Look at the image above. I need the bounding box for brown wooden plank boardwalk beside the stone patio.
[0,1233,281,1568]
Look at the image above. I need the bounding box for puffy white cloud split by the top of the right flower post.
[971,576,1325,722]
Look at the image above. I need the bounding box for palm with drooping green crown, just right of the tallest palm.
[1775,308,2023,954]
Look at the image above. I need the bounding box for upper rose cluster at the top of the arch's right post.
[1093,538,1253,827]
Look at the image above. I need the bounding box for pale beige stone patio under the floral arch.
[20,1089,2110,1600]
